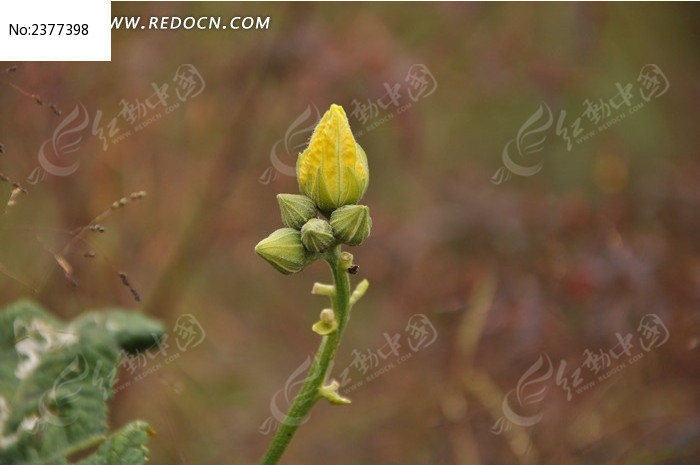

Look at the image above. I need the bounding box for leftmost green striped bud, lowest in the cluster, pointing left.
[255,228,312,274]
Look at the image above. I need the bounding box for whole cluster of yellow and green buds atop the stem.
[255,105,372,274]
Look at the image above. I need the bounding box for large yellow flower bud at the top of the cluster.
[297,105,369,213]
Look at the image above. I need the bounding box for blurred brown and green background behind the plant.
[0,2,700,464]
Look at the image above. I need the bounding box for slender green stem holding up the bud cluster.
[262,245,350,465]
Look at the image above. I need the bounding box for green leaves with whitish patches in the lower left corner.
[0,300,164,464]
